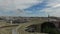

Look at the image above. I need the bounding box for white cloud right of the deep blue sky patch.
[42,0,60,17]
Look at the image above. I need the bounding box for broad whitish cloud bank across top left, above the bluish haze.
[0,0,41,9]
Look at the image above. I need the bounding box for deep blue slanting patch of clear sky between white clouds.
[24,0,48,11]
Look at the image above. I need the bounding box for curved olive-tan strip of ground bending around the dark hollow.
[16,22,45,34]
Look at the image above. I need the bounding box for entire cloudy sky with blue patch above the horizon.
[0,0,60,17]
